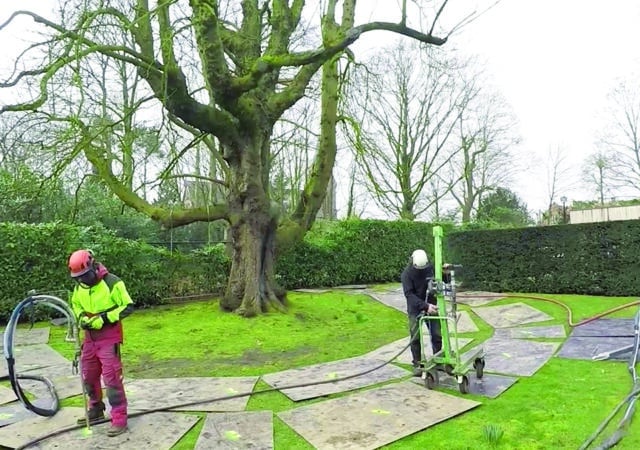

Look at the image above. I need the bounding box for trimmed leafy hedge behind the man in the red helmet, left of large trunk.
[0,223,229,322]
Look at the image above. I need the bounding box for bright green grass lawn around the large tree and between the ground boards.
[33,291,640,450]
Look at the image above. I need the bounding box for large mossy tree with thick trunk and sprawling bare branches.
[0,0,460,316]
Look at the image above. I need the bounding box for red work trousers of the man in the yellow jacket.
[80,339,127,427]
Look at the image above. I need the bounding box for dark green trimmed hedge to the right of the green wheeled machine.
[446,220,640,296]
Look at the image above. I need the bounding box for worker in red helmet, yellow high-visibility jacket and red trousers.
[68,250,133,436]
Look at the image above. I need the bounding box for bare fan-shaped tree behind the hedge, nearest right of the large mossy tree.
[347,43,477,220]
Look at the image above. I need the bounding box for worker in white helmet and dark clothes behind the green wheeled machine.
[401,249,442,376]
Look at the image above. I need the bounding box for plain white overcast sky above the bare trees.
[0,0,640,218]
